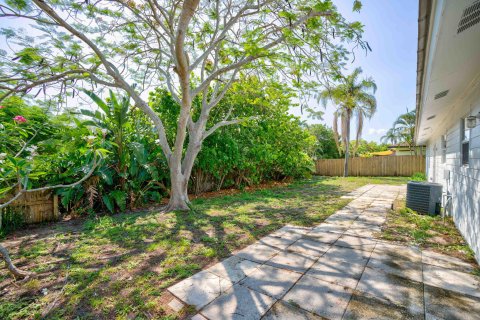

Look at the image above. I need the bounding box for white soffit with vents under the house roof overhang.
[417,0,480,144]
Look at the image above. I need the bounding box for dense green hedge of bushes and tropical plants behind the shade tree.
[0,77,319,214]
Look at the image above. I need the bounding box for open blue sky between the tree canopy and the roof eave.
[291,0,418,142]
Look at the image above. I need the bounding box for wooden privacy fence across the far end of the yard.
[315,156,425,177]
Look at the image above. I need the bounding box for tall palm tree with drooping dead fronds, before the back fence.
[319,68,377,177]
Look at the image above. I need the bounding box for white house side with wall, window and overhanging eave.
[415,0,480,262]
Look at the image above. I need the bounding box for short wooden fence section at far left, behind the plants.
[0,191,60,228]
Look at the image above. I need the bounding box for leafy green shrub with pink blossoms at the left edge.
[0,97,100,198]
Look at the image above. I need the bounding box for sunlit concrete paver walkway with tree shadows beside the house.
[168,185,480,320]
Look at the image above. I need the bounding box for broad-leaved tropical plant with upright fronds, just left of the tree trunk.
[81,90,166,212]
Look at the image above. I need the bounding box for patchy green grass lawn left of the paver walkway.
[0,177,408,319]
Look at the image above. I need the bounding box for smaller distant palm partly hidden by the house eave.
[382,109,417,155]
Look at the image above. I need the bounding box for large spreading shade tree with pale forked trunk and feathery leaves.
[0,0,369,210]
